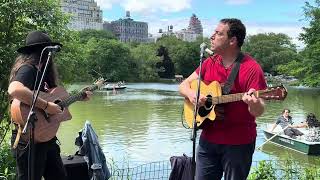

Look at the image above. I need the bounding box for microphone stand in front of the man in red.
[191,44,206,179]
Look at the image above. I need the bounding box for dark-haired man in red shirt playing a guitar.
[179,19,267,180]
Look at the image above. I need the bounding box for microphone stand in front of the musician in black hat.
[22,48,52,180]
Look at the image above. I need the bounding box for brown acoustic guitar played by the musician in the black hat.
[10,79,105,143]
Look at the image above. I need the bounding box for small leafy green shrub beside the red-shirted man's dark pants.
[248,160,277,180]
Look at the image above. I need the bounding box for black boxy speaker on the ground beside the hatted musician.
[61,155,90,180]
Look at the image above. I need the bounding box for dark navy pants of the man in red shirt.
[196,138,255,180]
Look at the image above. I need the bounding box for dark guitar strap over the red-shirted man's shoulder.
[222,52,244,95]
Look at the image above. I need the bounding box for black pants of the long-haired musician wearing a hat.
[12,133,66,180]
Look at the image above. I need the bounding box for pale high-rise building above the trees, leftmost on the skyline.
[60,0,103,30]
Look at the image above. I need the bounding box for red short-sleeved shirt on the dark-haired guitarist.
[196,54,267,145]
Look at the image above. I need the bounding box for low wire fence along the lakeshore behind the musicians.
[109,160,320,180]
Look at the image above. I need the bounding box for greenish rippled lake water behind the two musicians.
[58,83,320,165]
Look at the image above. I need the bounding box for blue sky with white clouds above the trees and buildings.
[96,0,308,48]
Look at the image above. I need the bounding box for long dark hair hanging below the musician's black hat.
[9,48,58,88]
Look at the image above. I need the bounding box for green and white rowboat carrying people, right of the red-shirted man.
[263,126,320,155]
